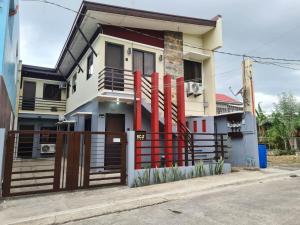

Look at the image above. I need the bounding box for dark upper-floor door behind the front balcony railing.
[105,43,124,91]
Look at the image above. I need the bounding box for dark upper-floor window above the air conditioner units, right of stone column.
[184,60,202,83]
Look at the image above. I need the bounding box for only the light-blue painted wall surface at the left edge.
[0,0,19,111]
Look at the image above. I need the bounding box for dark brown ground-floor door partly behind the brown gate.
[104,114,125,169]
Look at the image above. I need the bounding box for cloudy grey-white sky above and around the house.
[20,0,300,112]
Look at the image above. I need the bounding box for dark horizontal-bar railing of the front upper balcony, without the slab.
[98,67,134,92]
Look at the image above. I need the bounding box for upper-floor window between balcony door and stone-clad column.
[133,50,155,75]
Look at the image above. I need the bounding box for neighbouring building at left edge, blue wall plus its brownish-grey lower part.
[0,0,19,130]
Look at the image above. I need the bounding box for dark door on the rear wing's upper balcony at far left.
[22,81,35,110]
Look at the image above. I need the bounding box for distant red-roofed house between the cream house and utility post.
[216,94,243,114]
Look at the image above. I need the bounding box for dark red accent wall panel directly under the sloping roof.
[102,25,164,48]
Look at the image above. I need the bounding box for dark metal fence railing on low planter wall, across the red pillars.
[135,132,229,168]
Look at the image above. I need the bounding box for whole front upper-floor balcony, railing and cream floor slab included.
[98,67,134,100]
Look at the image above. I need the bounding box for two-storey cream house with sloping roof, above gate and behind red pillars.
[19,2,222,137]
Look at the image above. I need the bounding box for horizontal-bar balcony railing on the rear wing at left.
[19,96,66,112]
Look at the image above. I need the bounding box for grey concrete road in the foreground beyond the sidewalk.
[68,177,300,225]
